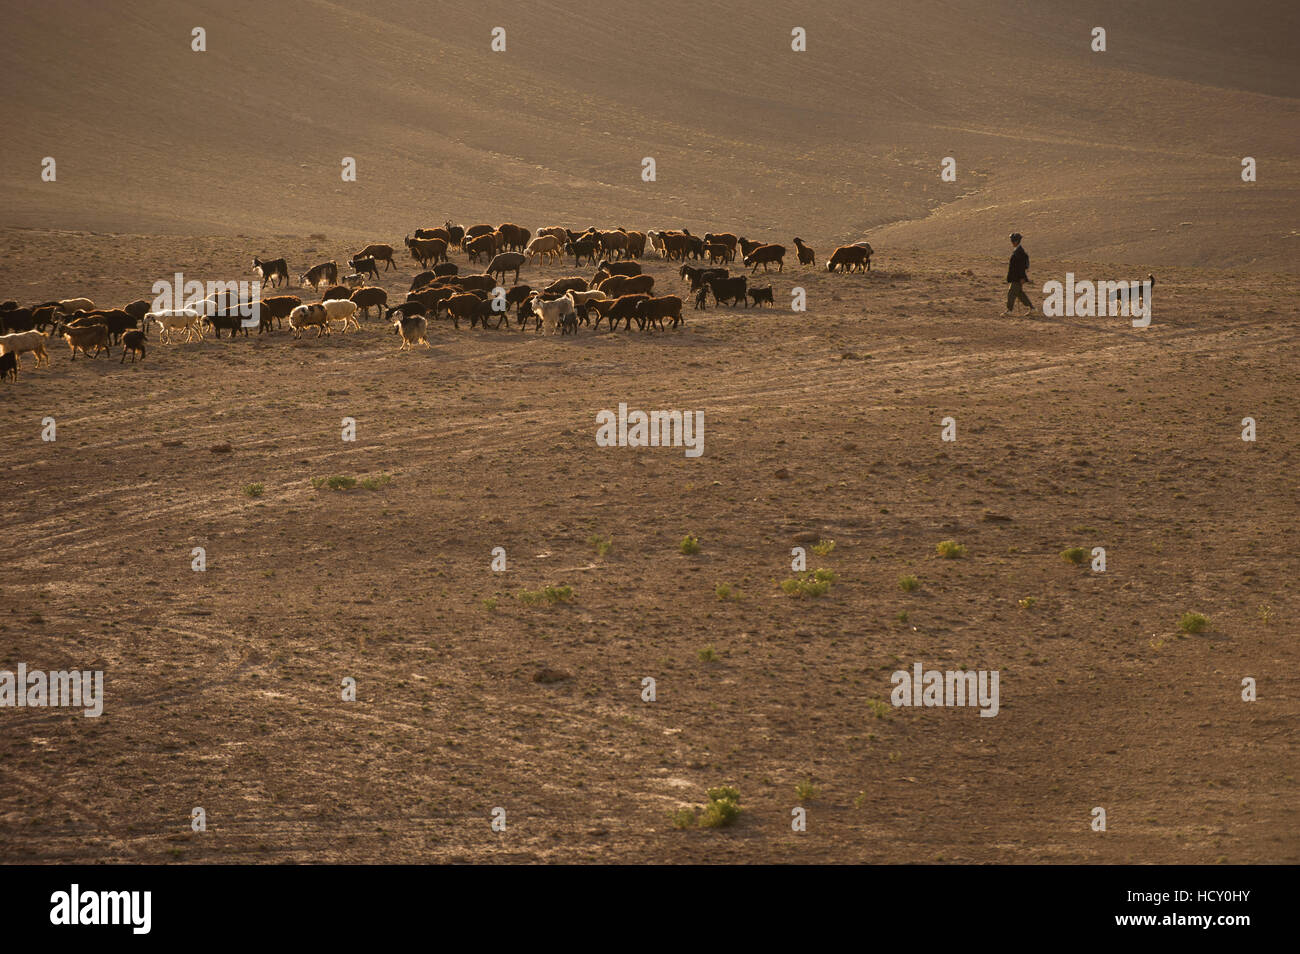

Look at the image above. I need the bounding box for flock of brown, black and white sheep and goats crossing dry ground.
[0,222,872,381]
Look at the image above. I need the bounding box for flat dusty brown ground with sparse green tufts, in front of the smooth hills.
[0,231,1300,863]
